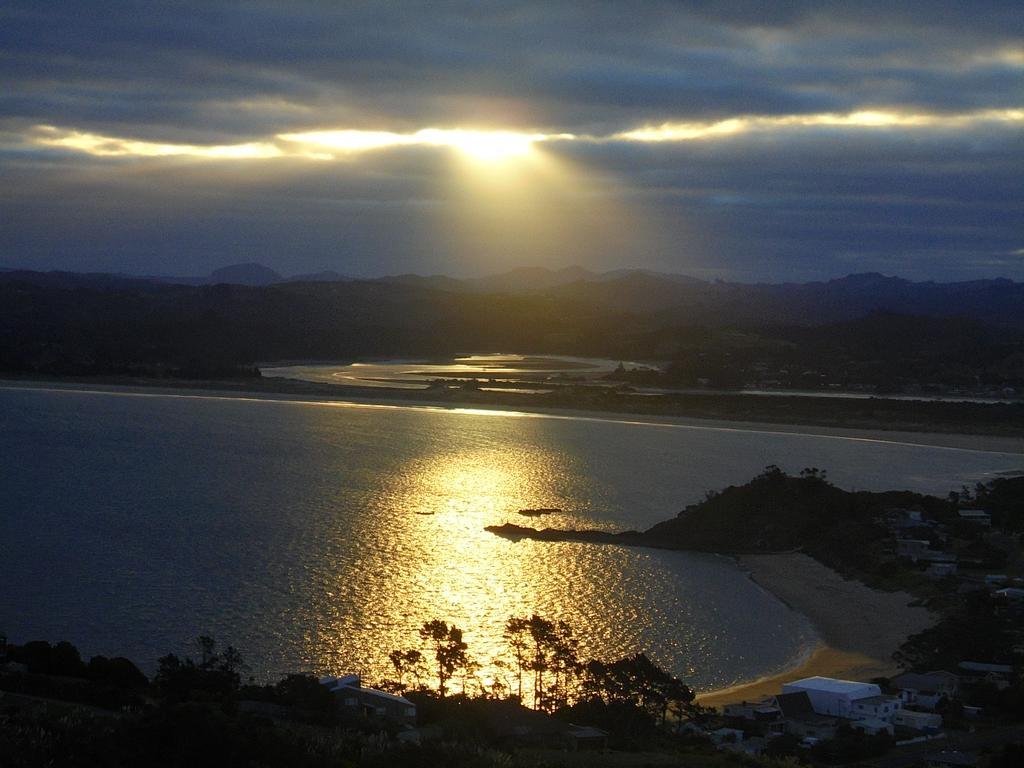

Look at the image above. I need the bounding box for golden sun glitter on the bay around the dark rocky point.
[278,417,815,690]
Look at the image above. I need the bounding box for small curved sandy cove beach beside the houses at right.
[697,553,936,707]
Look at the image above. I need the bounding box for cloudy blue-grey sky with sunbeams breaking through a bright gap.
[0,0,1024,282]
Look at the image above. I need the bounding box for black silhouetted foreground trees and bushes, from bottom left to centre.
[0,615,730,767]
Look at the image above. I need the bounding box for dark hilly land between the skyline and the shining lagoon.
[6,265,1024,392]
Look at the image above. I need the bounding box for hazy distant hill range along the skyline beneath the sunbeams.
[0,263,1024,329]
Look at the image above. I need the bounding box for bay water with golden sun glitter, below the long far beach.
[0,389,1024,689]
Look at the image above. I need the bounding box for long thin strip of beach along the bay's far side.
[6,377,1024,456]
